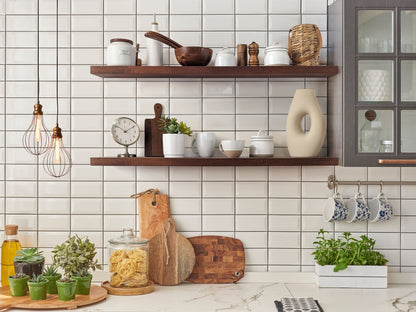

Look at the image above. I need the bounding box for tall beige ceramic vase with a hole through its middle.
[286,89,326,157]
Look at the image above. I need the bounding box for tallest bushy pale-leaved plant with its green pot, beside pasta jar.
[52,235,101,295]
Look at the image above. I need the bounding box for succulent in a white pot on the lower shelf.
[159,116,192,157]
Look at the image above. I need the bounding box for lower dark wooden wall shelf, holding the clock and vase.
[90,157,338,166]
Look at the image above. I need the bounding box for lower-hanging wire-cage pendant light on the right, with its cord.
[43,0,72,178]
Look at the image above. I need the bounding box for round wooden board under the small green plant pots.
[0,285,107,310]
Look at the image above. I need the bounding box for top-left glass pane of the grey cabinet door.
[357,10,394,53]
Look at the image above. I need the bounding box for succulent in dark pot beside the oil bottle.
[13,248,45,277]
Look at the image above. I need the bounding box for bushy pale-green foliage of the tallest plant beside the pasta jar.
[52,235,101,281]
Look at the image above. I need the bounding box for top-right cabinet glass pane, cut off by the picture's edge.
[400,10,416,53]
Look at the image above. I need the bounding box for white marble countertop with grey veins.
[6,282,416,312]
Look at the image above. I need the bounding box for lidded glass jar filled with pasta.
[108,229,149,287]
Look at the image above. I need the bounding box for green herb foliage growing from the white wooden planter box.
[312,229,388,272]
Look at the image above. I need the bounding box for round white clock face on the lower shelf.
[111,117,140,146]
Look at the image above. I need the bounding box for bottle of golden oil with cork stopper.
[1,224,21,286]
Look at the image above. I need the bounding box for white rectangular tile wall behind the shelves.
[0,0,416,272]
